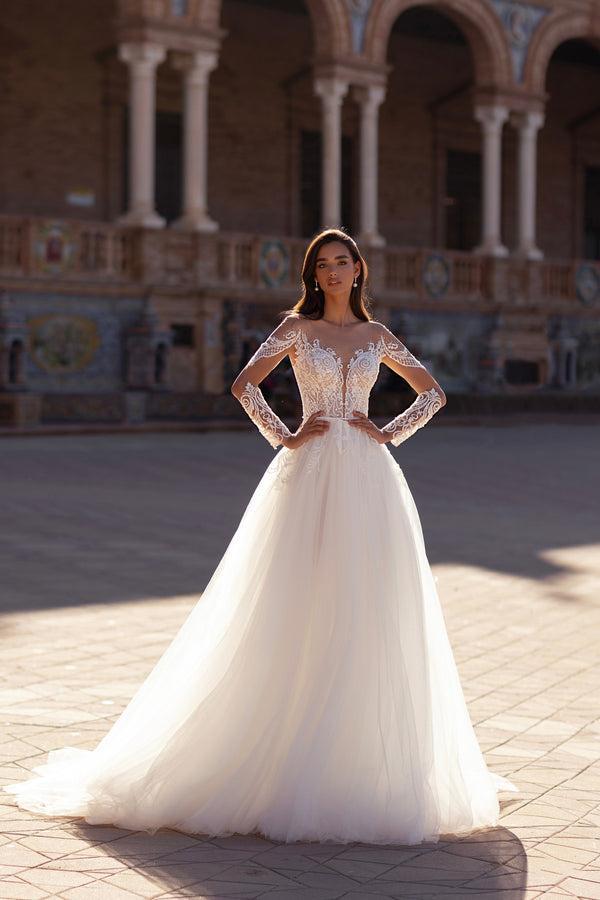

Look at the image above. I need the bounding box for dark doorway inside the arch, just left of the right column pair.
[444,150,481,251]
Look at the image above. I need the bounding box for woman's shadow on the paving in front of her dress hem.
[76,826,527,900]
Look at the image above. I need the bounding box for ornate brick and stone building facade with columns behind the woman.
[0,0,600,422]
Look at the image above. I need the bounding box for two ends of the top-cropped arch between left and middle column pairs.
[190,0,352,62]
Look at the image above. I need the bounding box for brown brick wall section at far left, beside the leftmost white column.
[0,0,114,218]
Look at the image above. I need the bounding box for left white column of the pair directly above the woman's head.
[315,78,348,228]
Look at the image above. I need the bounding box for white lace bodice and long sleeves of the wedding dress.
[240,320,442,447]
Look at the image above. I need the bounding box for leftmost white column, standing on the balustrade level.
[119,43,166,228]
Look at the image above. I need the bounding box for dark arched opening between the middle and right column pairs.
[380,5,481,251]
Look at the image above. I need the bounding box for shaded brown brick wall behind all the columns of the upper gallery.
[0,0,600,260]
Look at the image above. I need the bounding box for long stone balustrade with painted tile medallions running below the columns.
[0,216,600,311]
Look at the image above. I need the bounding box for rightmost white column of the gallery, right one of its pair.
[512,111,544,259]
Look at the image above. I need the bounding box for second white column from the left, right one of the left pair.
[172,51,219,232]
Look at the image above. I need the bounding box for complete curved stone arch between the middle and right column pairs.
[364,0,513,88]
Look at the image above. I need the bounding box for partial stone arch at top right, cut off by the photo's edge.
[523,11,600,95]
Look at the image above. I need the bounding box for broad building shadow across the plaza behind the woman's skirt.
[0,425,600,612]
